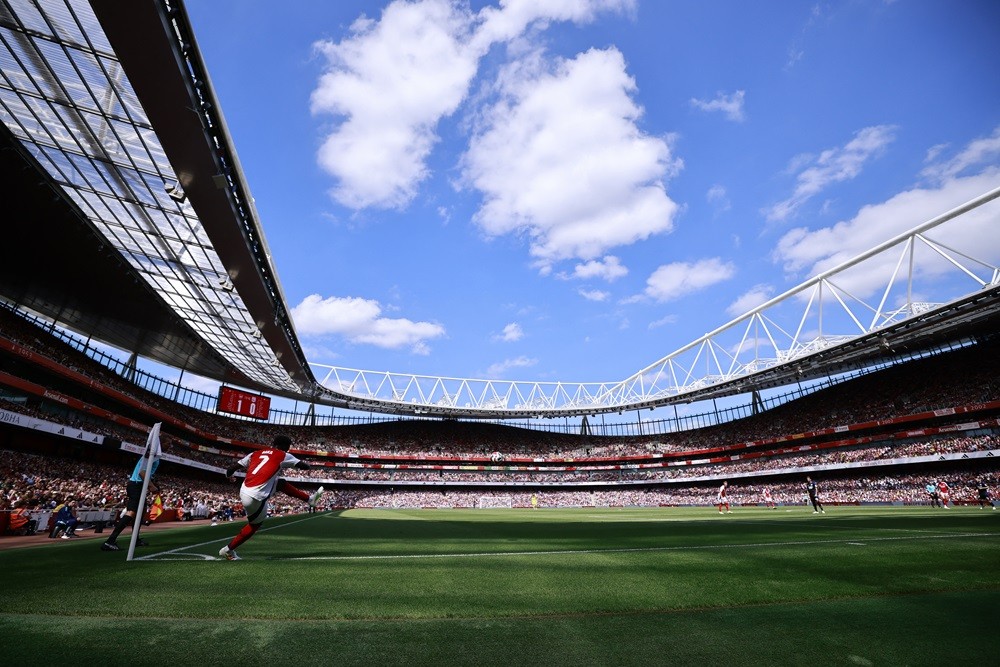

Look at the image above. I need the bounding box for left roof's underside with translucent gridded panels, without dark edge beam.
[0,0,300,394]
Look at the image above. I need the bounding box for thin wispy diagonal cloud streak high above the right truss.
[763,125,896,222]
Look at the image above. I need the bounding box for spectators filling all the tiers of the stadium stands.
[0,308,1000,540]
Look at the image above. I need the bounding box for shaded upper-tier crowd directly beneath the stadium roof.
[0,308,1000,461]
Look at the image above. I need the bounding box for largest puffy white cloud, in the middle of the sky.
[463,49,680,274]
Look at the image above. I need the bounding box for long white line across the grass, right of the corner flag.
[270,533,997,561]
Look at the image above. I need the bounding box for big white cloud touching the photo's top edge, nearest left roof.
[311,0,634,209]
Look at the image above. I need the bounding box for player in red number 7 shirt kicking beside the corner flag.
[219,435,323,560]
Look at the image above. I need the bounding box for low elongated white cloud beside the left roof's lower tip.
[291,294,445,354]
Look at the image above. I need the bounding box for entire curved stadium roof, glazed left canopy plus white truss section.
[0,0,1000,418]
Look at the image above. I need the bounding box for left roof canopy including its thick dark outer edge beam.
[0,2,314,395]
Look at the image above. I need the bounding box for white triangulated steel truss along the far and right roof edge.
[311,187,1000,419]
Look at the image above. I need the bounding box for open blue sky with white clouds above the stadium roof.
[186,0,1000,392]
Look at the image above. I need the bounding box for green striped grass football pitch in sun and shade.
[0,506,1000,667]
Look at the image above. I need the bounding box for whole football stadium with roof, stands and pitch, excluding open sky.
[0,0,1000,666]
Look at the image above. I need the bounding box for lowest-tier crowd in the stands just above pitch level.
[0,450,1000,532]
